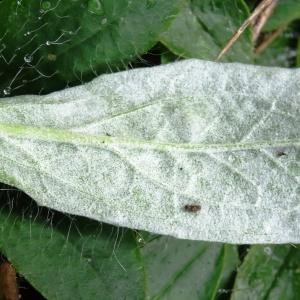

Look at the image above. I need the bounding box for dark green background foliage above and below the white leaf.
[0,0,300,299]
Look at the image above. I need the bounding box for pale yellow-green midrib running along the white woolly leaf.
[0,123,300,152]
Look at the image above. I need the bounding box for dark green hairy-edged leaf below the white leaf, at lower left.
[0,188,145,300]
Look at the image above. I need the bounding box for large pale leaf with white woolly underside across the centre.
[0,60,300,243]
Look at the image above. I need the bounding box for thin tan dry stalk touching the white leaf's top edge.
[217,0,277,60]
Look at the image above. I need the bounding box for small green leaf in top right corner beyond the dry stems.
[264,0,300,31]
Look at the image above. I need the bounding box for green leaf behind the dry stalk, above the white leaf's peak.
[161,0,252,62]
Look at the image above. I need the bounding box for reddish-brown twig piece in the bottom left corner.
[0,261,19,300]
